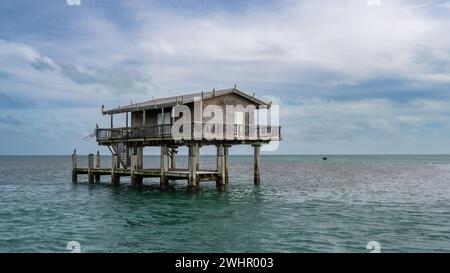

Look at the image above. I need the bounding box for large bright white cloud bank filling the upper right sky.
[110,1,450,85]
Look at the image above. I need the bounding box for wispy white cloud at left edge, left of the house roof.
[0,39,153,105]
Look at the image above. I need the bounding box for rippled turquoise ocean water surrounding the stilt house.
[0,155,450,252]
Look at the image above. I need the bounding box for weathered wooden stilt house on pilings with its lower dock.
[73,86,281,190]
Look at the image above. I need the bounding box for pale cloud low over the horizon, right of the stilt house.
[281,95,450,153]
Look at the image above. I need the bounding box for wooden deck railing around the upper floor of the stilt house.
[95,123,281,141]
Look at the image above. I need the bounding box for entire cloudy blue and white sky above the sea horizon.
[0,0,450,154]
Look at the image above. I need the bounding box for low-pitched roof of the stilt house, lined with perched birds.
[103,88,269,115]
